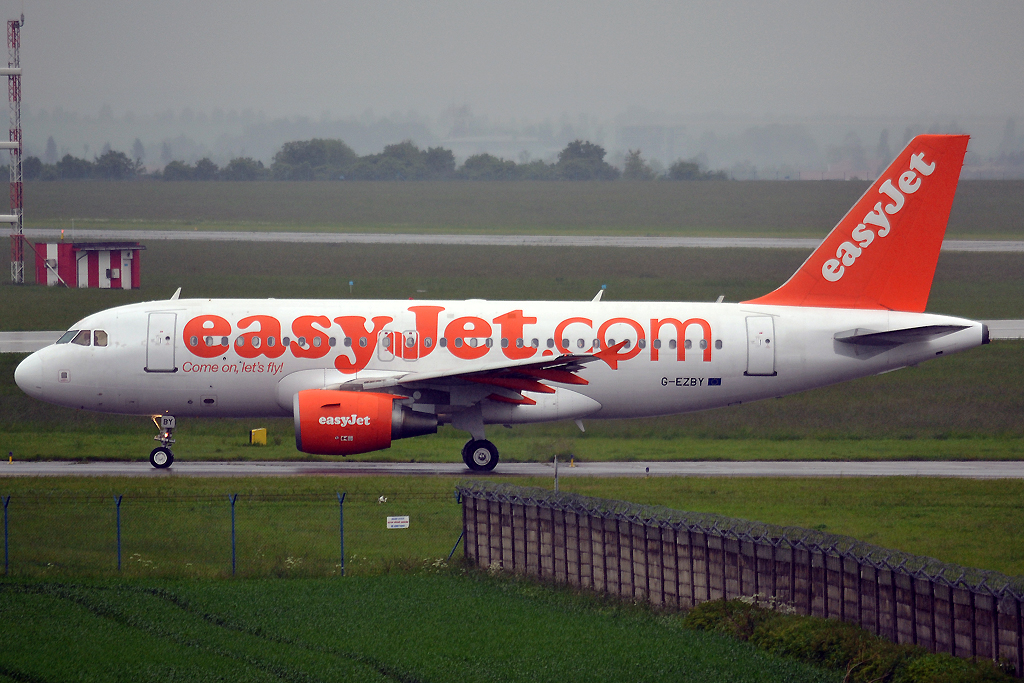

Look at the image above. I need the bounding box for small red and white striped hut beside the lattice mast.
[36,242,145,290]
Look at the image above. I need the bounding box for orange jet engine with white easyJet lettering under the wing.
[292,389,437,456]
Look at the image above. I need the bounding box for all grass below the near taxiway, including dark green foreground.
[0,477,1011,681]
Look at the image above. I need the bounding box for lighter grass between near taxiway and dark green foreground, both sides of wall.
[0,479,1024,579]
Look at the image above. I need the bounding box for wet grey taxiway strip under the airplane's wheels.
[0,461,1024,481]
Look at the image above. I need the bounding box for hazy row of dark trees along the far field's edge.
[23,138,728,181]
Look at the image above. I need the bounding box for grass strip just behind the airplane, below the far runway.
[6,238,1024,330]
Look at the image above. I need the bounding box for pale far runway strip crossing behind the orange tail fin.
[25,228,1024,253]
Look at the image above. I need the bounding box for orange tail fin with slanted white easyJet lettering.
[744,135,969,312]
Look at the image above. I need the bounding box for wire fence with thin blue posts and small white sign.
[0,489,461,578]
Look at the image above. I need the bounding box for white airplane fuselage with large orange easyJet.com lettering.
[9,299,982,423]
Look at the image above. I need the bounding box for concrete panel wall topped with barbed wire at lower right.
[457,482,1024,675]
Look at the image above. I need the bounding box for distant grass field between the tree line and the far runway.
[12,180,1024,239]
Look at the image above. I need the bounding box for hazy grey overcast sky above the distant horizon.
[0,0,1024,120]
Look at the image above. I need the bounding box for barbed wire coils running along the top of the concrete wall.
[456,480,1024,600]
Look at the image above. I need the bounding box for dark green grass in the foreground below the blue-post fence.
[0,571,841,683]
